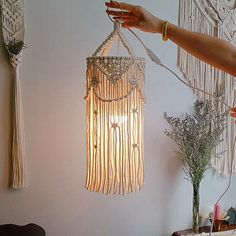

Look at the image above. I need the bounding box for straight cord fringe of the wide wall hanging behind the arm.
[178,0,236,176]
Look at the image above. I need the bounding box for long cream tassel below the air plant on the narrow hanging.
[11,55,27,189]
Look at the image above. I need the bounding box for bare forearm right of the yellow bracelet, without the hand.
[167,21,236,76]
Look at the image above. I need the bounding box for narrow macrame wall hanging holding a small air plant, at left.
[1,0,27,189]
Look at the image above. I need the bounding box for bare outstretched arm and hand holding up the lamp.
[106,1,236,76]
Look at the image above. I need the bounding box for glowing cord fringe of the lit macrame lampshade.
[86,61,144,195]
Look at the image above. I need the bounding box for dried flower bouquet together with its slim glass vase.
[164,97,227,233]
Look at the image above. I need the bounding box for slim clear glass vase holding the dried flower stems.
[192,184,200,233]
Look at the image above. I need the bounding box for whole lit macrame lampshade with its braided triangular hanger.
[85,22,145,195]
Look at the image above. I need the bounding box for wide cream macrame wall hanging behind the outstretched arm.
[178,0,236,175]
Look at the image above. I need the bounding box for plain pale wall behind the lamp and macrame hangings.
[0,0,236,236]
